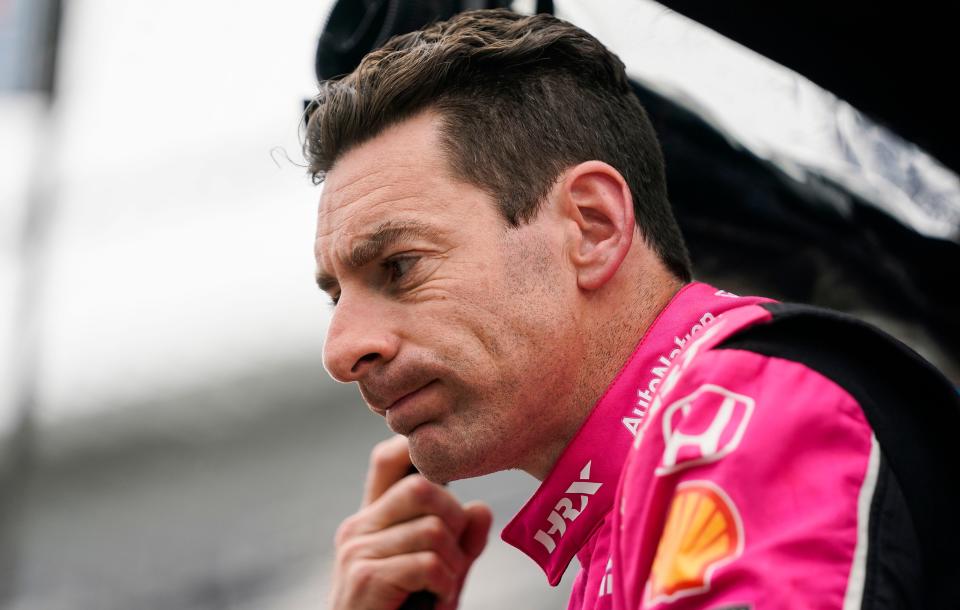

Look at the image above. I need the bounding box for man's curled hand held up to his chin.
[330,436,493,610]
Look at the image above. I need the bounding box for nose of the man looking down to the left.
[323,295,400,383]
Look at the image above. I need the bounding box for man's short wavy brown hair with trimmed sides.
[304,10,691,281]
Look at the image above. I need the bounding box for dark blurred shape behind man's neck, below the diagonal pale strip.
[634,84,960,370]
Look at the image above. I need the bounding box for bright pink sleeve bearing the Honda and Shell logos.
[613,349,879,610]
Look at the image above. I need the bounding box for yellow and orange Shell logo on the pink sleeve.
[645,481,743,605]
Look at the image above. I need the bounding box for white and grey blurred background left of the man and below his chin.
[0,0,574,610]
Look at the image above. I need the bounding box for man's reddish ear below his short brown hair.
[555,161,635,290]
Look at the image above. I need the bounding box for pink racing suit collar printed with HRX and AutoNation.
[500,282,754,586]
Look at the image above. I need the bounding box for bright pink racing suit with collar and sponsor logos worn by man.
[502,283,960,610]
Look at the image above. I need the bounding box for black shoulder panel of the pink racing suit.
[718,303,960,608]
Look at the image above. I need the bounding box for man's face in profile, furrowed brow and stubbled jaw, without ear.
[316,113,580,481]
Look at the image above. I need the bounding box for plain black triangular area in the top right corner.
[661,0,960,177]
